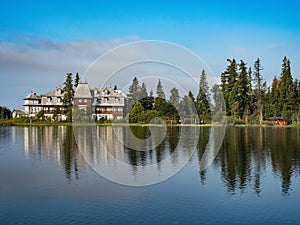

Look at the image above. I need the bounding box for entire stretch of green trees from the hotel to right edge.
[127,57,300,124]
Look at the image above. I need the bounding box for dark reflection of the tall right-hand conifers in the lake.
[204,127,300,195]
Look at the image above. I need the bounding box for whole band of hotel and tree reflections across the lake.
[24,126,300,195]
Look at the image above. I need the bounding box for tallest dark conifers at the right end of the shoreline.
[220,57,300,124]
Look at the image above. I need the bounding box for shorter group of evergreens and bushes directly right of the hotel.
[126,70,211,123]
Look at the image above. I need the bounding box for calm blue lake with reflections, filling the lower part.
[0,126,300,225]
